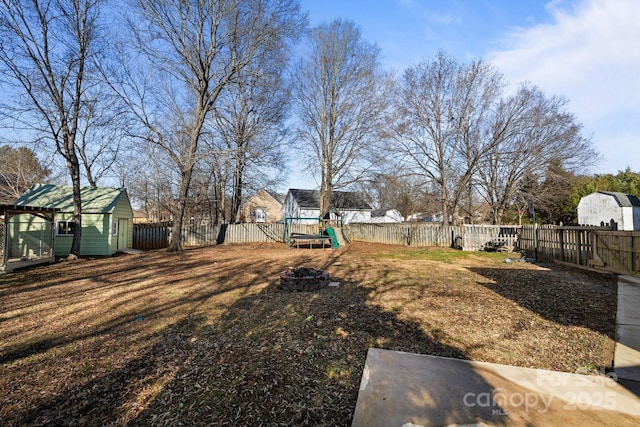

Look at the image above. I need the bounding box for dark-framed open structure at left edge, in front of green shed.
[0,205,60,272]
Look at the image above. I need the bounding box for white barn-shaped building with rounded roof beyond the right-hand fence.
[578,191,640,231]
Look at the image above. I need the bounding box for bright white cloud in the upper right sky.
[489,0,640,172]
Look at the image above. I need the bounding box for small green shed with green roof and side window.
[9,184,133,257]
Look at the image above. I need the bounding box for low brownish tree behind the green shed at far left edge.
[0,145,50,203]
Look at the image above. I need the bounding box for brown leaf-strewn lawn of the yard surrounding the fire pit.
[0,243,616,426]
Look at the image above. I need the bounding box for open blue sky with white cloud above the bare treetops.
[290,0,640,188]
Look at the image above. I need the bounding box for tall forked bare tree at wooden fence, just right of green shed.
[117,0,302,251]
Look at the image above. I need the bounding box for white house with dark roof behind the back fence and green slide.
[282,188,371,224]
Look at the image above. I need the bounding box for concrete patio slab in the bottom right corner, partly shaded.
[352,348,640,427]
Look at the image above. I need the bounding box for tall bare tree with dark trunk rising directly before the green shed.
[0,0,101,257]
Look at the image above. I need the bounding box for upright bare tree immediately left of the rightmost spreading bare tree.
[393,52,503,227]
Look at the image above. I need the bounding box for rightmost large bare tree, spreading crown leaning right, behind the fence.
[477,85,598,224]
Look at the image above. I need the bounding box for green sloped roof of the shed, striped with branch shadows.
[14,184,126,213]
